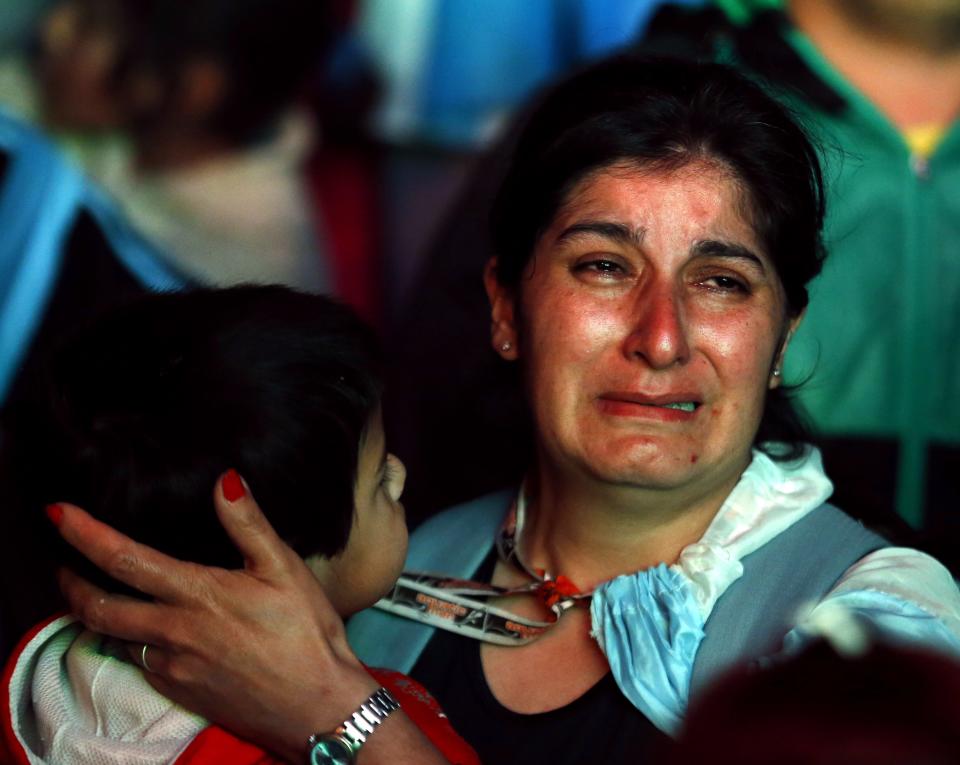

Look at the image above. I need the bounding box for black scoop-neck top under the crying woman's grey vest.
[410,552,667,765]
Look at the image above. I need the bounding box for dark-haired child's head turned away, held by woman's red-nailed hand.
[15,287,407,613]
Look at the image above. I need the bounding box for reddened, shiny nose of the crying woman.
[624,284,690,369]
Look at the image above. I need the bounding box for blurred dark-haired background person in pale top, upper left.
[0,0,331,291]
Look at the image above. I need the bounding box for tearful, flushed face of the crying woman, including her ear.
[487,162,791,491]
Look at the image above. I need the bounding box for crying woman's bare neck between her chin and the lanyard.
[521,456,746,590]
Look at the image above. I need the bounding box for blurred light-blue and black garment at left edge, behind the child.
[0,106,191,412]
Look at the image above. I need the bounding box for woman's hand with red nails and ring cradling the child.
[51,474,443,763]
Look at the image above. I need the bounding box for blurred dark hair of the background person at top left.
[86,0,332,143]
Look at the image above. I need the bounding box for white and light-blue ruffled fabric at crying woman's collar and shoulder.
[591,449,960,733]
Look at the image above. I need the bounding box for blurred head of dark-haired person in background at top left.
[40,0,331,144]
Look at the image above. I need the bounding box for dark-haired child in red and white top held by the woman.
[4,287,477,765]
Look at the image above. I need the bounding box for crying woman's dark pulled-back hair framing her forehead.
[491,54,825,459]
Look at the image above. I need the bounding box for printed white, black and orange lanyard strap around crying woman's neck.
[376,489,593,645]
